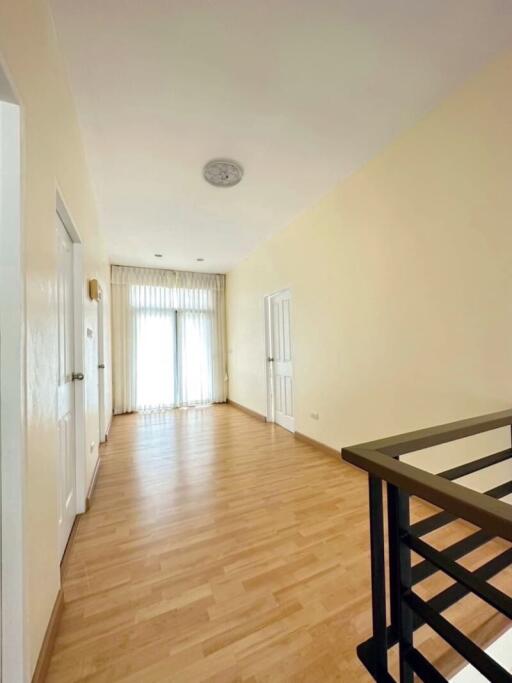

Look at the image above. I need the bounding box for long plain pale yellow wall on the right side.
[227,53,512,469]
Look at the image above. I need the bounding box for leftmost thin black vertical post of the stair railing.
[368,475,388,680]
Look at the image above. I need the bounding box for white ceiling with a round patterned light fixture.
[51,0,512,272]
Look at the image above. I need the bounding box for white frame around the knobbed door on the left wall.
[56,190,87,514]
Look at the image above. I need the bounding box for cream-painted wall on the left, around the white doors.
[0,0,110,668]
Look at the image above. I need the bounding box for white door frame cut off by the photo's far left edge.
[0,61,29,683]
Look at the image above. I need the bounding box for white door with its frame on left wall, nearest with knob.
[55,192,86,559]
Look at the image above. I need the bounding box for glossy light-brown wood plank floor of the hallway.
[47,406,510,683]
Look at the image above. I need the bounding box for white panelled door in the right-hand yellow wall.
[267,290,295,432]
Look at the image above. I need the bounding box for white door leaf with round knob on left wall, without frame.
[57,215,76,557]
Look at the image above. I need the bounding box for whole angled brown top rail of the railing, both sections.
[342,410,512,541]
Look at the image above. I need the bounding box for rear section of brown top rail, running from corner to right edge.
[350,410,512,457]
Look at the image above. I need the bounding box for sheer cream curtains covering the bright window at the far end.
[112,266,226,414]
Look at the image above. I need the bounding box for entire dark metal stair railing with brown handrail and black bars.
[342,410,512,683]
